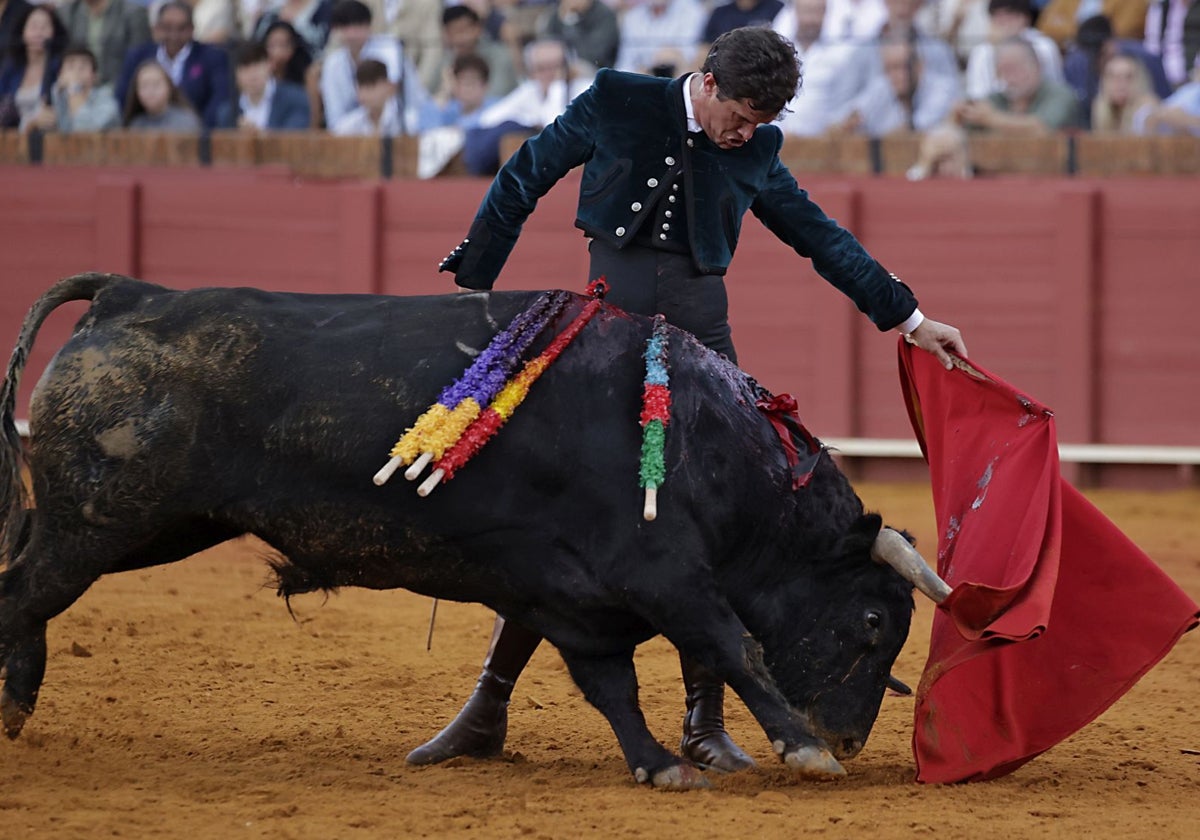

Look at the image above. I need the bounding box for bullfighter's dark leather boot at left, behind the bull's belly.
[404,616,541,764]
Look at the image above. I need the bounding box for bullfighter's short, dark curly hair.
[700,26,800,114]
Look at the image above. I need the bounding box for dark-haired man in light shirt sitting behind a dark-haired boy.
[320,0,430,133]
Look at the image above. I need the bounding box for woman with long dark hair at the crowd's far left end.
[0,5,67,131]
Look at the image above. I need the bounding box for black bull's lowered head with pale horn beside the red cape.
[761,515,949,758]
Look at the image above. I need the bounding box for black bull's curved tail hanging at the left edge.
[0,274,119,565]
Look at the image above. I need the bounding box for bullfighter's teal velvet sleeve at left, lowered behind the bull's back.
[438,71,606,289]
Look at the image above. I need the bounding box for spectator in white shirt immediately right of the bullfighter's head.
[774,0,878,137]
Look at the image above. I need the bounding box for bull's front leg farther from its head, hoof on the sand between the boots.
[560,650,708,790]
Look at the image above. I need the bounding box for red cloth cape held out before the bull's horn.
[900,341,1200,782]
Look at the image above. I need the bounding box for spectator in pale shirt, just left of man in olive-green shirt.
[835,34,961,137]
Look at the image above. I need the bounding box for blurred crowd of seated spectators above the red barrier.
[0,0,1200,178]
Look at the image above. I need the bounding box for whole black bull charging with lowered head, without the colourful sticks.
[0,275,926,786]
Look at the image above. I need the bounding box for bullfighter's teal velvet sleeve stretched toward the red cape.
[750,127,917,330]
